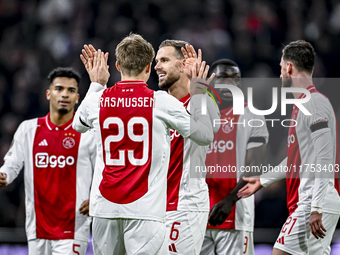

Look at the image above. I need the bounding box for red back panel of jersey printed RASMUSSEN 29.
[99,80,154,204]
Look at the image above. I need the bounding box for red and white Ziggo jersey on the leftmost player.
[0,114,96,241]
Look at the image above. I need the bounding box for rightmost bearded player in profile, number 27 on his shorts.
[239,40,340,255]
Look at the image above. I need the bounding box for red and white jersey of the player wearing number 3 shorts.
[205,104,268,231]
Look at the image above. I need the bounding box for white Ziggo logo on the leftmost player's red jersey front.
[35,152,75,168]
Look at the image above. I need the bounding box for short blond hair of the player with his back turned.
[115,33,155,76]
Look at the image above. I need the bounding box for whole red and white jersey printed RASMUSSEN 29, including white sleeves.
[73,81,213,222]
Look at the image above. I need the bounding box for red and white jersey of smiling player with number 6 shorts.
[166,94,220,212]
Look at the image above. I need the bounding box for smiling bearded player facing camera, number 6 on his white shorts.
[155,40,220,254]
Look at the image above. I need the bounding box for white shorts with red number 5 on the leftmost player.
[28,239,88,255]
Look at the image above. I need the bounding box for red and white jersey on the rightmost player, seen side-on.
[286,85,340,214]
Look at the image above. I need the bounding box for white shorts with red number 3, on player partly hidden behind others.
[201,229,254,255]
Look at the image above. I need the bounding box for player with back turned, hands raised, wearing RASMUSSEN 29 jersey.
[73,34,213,255]
